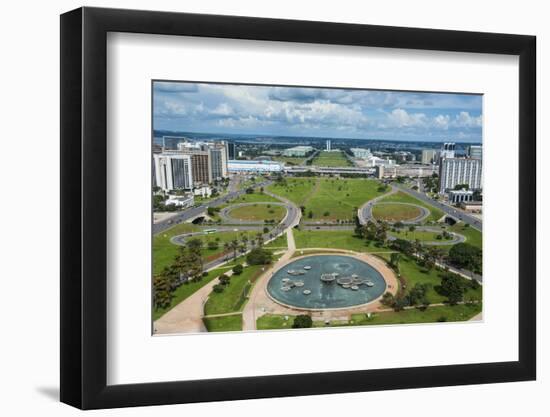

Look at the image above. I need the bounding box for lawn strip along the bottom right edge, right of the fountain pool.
[351,303,482,326]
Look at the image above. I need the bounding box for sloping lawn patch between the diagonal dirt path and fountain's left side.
[204,265,262,316]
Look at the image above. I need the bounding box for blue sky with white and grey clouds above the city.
[153,82,482,142]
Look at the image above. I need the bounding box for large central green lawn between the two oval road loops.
[269,178,384,222]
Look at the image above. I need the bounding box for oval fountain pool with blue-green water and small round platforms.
[267,255,386,310]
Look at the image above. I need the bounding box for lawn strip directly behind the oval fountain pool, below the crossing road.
[292,229,391,252]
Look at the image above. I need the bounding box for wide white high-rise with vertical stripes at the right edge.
[439,158,483,194]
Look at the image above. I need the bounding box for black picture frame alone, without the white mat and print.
[60,7,536,409]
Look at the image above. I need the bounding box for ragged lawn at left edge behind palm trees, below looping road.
[153,223,256,275]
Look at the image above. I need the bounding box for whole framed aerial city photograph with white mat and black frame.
[61,8,536,409]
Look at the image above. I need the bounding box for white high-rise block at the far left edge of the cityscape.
[153,153,193,191]
